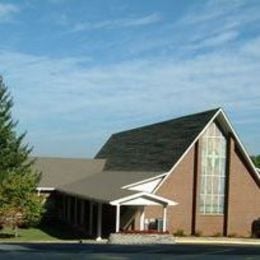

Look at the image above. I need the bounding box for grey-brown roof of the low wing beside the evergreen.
[33,157,105,188]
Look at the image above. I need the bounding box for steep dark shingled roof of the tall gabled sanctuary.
[95,109,219,171]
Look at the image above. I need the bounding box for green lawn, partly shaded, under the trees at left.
[0,224,85,242]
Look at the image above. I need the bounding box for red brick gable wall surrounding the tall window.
[145,125,260,237]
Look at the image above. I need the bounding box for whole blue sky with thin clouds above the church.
[0,0,260,157]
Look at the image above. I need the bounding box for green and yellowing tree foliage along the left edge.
[0,77,43,234]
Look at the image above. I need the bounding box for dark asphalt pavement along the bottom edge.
[0,243,260,260]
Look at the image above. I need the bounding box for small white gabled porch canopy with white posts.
[110,192,178,232]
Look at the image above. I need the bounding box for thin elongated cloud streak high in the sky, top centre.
[72,14,161,32]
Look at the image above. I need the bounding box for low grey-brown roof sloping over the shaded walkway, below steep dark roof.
[57,171,161,202]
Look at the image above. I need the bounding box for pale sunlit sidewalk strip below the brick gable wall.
[175,237,260,246]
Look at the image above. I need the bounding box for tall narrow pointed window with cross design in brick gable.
[200,123,227,214]
